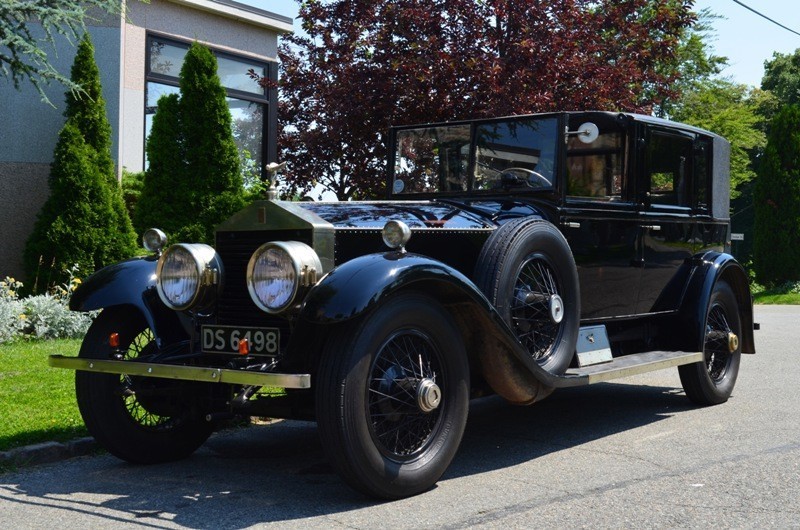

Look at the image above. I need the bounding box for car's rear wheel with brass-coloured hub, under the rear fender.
[678,280,742,406]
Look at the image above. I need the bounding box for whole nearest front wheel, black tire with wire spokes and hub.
[316,293,469,499]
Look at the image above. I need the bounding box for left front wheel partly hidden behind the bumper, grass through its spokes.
[75,309,212,464]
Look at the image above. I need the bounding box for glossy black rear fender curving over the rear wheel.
[676,252,756,353]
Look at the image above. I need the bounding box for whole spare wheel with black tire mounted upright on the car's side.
[475,218,581,374]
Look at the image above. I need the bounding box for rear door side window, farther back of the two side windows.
[645,131,694,207]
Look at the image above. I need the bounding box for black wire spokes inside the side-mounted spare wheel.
[511,255,561,361]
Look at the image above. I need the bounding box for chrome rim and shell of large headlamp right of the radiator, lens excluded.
[246,241,322,315]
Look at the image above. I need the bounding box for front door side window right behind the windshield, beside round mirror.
[567,119,625,201]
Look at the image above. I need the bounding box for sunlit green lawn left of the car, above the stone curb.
[0,340,88,451]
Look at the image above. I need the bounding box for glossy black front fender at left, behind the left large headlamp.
[69,256,186,343]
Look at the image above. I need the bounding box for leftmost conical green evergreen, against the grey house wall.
[24,33,136,290]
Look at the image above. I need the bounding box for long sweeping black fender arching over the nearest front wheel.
[296,252,559,404]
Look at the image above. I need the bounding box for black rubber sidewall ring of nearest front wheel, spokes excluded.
[317,294,469,498]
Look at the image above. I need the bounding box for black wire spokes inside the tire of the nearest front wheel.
[367,330,445,460]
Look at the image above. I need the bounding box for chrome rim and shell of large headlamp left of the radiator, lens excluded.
[156,243,222,311]
